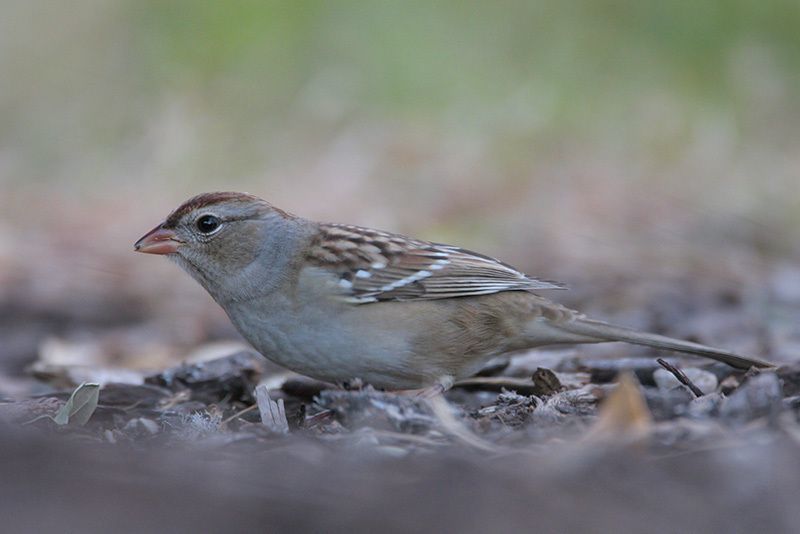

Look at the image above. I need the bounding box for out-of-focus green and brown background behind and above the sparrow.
[0,0,800,393]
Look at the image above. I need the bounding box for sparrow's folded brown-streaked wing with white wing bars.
[306,224,564,304]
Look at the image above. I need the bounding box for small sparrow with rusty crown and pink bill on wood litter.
[134,192,773,392]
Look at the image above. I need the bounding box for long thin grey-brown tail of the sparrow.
[558,319,775,369]
